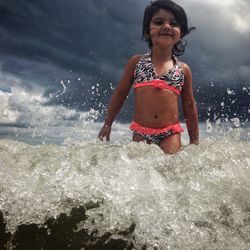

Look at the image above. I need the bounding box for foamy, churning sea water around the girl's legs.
[0,120,250,249]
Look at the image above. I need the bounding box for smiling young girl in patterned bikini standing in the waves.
[98,0,199,154]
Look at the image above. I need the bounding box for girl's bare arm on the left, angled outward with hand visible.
[98,55,141,141]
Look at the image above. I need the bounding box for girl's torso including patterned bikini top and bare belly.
[133,54,184,128]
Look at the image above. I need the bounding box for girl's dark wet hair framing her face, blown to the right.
[142,0,195,56]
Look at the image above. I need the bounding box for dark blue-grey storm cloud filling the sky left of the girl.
[0,0,147,116]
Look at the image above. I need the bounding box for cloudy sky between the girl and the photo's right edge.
[178,0,250,120]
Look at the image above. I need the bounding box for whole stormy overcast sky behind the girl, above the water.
[0,0,250,126]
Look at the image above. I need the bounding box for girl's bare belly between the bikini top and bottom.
[134,86,179,128]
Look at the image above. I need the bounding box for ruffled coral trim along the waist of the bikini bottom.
[129,121,184,135]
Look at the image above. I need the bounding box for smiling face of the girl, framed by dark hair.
[149,9,181,48]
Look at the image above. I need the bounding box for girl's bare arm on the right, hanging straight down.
[181,63,199,145]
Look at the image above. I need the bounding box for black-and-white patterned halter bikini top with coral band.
[133,53,184,95]
